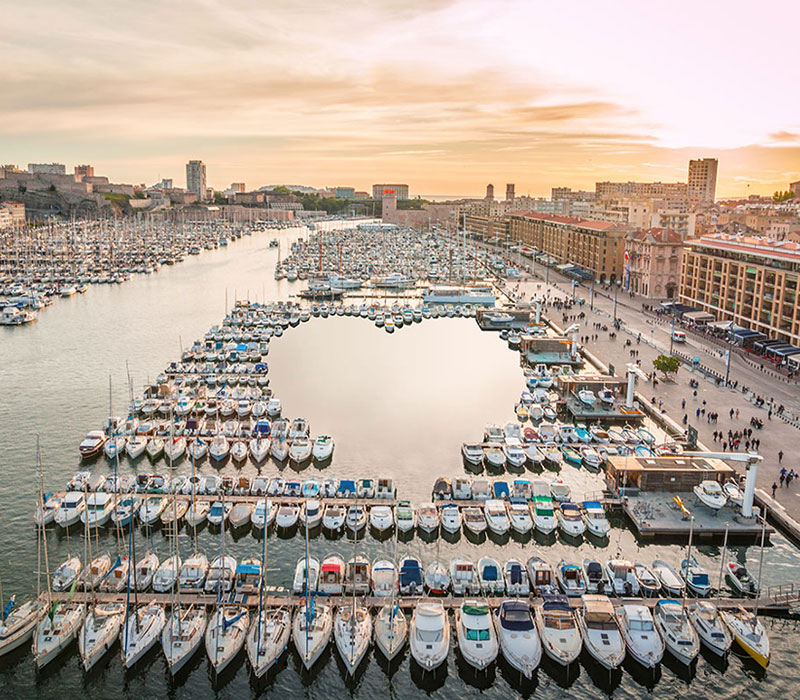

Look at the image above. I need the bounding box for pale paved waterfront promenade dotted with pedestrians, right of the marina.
[506,266,800,536]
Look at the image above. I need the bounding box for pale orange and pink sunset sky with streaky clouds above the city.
[0,0,800,196]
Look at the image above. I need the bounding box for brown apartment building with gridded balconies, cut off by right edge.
[680,233,800,345]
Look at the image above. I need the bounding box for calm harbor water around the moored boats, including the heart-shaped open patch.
[0,229,800,700]
